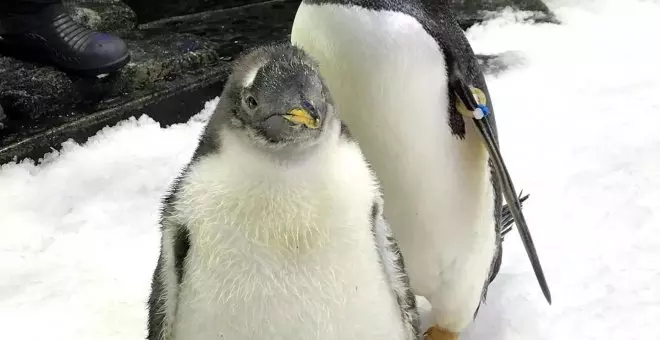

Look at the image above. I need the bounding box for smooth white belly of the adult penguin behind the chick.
[292,3,495,328]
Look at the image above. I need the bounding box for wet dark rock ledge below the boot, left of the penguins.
[0,0,299,164]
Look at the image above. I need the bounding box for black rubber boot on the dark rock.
[0,0,130,76]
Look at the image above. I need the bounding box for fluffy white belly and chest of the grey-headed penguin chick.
[174,139,405,340]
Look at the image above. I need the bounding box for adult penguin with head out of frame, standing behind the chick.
[291,0,551,340]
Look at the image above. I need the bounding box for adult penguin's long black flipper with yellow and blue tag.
[449,65,552,303]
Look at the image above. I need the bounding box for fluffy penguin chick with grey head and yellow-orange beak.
[148,44,420,340]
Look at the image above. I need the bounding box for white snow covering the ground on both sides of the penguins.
[0,0,660,340]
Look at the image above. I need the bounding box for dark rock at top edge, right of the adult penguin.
[449,0,558,29]
